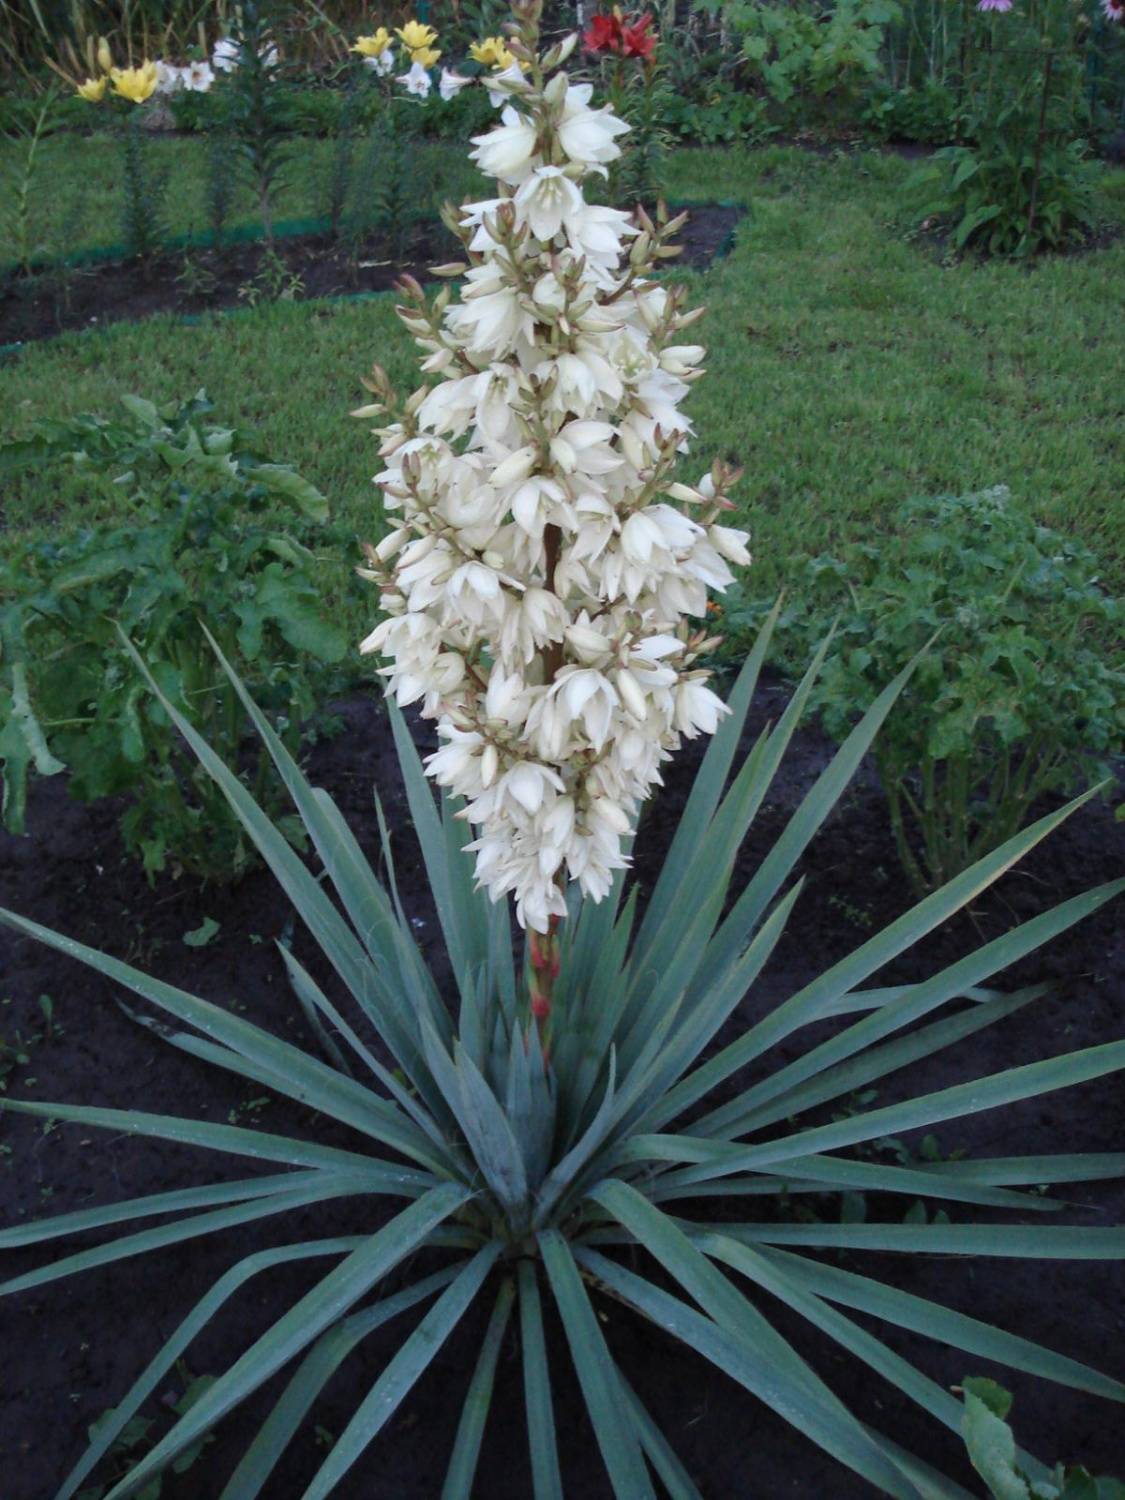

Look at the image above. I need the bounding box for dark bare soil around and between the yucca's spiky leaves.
[0,686,1125,1500]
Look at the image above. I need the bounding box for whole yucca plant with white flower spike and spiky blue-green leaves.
[0,0,1125,1500]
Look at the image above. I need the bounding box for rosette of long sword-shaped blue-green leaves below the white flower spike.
[0,617,1125,1500]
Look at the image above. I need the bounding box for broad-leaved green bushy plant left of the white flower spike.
[0,393,347,879]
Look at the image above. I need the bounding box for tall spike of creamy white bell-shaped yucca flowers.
[357,0,750,933]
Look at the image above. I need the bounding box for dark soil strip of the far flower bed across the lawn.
[0,204,744,345]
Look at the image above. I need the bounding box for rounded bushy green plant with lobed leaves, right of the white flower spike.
[732,488,1125,890]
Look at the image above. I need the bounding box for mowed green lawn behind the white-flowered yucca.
[0,132,1125,636]
